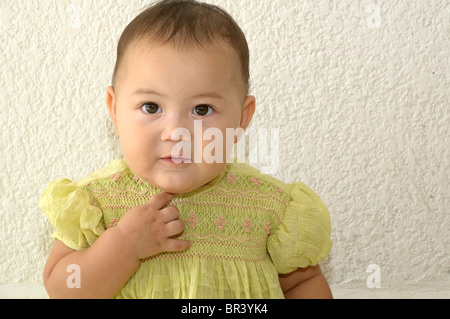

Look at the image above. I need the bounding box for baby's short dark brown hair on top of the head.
[112,0,250,91]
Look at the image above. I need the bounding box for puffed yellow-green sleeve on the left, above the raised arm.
[39,179,105,250]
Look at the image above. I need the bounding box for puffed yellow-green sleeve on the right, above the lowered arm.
[267,183,332,274]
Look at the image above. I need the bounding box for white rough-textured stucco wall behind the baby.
[0,0,450,297]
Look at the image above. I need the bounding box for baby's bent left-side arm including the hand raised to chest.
[44,193,191,298]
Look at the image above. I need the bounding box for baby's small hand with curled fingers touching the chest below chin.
[116,193,191,259]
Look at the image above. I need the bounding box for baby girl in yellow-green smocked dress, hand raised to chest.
[40,0,332,298]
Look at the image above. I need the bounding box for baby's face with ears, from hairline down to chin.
[107,45,255,193]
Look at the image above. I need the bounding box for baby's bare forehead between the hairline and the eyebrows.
[116,42,245,95]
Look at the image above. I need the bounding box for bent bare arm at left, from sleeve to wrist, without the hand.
[44,227,140,298]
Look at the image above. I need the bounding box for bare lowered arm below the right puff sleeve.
[279,265,333,299]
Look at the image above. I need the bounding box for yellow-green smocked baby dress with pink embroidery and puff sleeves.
[40,159,332,299]
